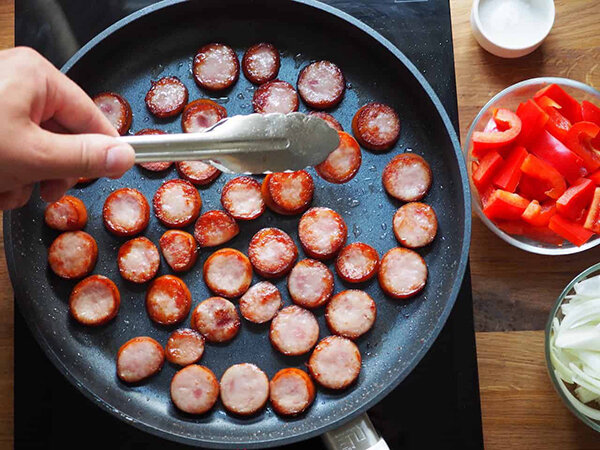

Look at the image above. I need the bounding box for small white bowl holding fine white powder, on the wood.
[471,0,556,58]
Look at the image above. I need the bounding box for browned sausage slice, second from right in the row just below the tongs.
[221,177,265,220]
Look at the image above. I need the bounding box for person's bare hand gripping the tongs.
[0,47,134,209]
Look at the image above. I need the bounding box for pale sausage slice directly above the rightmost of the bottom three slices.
[269,305,319,356]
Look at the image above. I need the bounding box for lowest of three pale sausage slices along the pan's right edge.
[378,247,427,298]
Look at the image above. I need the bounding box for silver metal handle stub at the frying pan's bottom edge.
[323,413,390,450]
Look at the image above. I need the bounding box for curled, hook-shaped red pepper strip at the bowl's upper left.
[472,108,521,158]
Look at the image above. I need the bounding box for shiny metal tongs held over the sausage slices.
[119,112,339,174]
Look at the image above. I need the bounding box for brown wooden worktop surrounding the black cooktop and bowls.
[0,0,600,450]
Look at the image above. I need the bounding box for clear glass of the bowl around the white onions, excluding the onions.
[544,263,600,431]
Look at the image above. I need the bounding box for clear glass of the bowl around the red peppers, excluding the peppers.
[463,77,600,255]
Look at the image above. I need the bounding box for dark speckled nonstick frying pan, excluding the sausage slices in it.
[4,0,471,448]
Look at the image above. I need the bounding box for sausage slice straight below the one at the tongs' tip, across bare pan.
[298,207,348,259]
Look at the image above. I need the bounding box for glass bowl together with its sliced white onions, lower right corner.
[545,263,600,431]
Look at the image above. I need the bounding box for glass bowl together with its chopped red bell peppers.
[464,78,600,255]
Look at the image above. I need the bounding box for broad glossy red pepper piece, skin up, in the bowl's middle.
[527,130,587,183]
